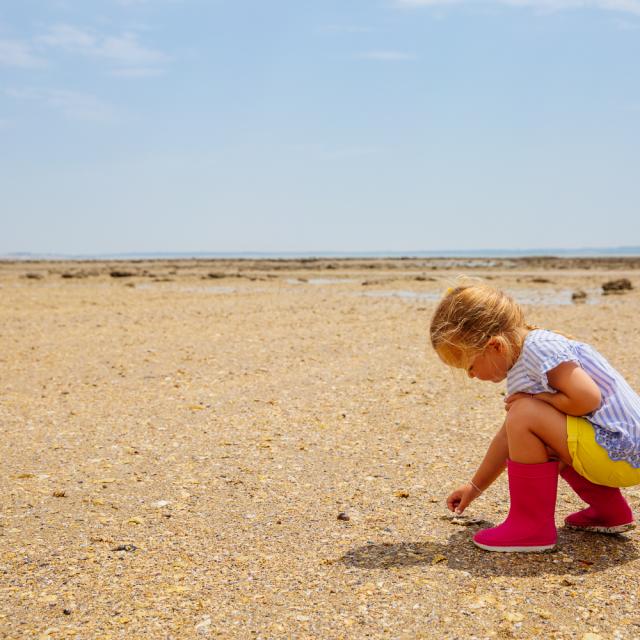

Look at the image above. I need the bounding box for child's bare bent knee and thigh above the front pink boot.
[505,398,571,465]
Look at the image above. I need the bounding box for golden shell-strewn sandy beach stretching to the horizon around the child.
[0,259,640,640]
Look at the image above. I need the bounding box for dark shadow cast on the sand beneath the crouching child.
[340,523,640,577]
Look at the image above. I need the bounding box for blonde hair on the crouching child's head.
[430,284,535,368]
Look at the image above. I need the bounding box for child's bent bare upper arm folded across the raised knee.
[505,362,602,416]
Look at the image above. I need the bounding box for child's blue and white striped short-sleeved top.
[507,329,640,468]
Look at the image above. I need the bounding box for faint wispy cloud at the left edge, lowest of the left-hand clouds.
[4,88,116,123]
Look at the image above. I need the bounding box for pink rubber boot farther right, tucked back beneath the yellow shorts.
[560,467,636,533]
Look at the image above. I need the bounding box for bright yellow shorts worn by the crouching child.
[567,416,640,487]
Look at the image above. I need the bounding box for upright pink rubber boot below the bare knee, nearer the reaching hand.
[473,460,558,552]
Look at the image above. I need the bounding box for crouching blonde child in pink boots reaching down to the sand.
[431,284,640,551]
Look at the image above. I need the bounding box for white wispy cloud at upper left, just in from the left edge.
[37,24,171,76]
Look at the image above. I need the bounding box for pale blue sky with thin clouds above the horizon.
[0,0,640,254]
